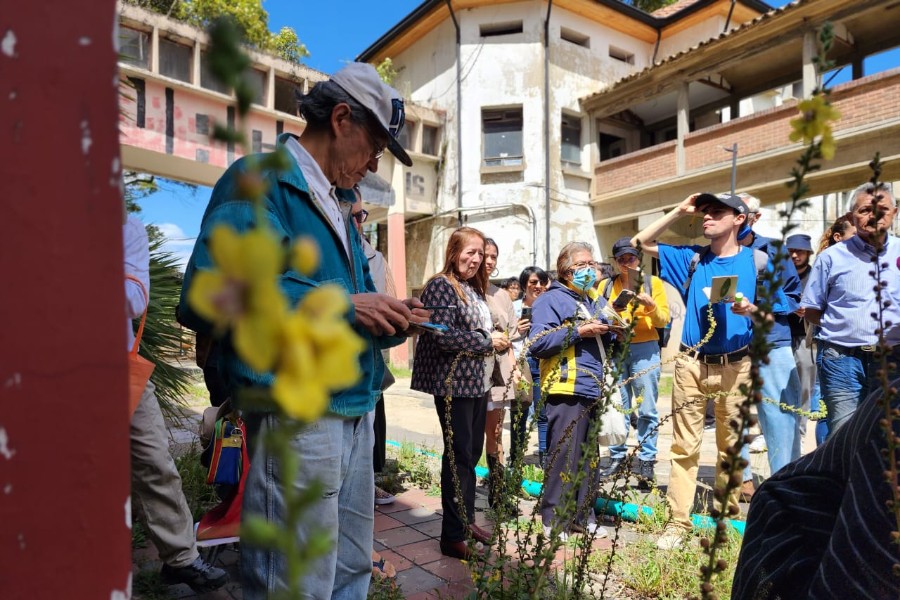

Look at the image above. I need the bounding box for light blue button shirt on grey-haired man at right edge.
[800,235,900,347]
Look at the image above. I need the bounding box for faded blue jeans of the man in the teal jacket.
[241,414,375,600]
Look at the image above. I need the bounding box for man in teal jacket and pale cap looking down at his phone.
[180,63,430,600]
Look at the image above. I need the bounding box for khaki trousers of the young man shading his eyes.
[666,357,750,529]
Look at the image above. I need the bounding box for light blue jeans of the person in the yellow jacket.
[609,340,659,461]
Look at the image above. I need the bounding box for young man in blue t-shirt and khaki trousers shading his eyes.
[632,193,768,550]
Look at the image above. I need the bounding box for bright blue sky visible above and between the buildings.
[140,0,900,264]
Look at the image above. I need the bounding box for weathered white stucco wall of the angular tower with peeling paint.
[392,1,653,285]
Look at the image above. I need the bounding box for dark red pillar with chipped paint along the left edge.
[0,0,131,600]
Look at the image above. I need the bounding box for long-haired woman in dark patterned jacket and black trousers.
[411,227,509,559]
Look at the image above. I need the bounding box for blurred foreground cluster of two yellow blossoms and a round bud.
[188,225,365,421]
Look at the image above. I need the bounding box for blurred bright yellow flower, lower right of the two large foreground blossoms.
[272,285,366,421]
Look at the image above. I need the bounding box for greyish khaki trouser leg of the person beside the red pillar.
[131,381,199,567]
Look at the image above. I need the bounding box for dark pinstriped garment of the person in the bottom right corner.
[731,379,900,600]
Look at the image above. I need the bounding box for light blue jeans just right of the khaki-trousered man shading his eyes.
[756,346,802,475]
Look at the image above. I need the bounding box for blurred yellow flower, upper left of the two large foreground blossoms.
[188,225,287,372]
